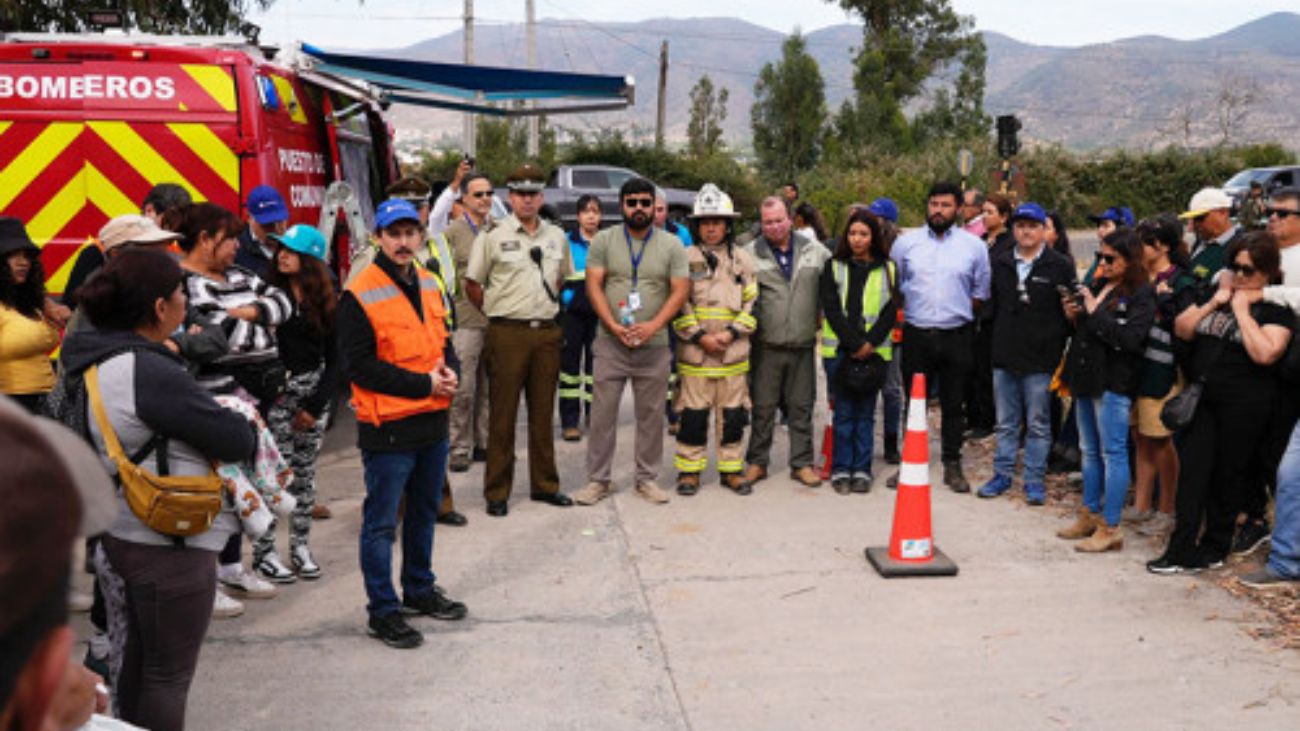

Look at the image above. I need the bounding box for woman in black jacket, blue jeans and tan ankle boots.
[1057,228,1156,553]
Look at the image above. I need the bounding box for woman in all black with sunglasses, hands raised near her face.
[1147,232,1292,574]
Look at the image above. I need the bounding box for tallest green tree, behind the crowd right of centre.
[835,0,989,151]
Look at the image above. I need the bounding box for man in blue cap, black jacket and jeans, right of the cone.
[976,203,1078,505]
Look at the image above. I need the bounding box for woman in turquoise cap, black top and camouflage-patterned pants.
[252,224,341,583]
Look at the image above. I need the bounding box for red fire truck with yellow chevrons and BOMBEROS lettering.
[0,34,397,293]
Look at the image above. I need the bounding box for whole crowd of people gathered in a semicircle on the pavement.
[0,165,1300,731]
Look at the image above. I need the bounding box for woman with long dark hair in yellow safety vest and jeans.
[820,209,897,494]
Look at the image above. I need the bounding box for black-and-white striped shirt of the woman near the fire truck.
[185,265,294,393]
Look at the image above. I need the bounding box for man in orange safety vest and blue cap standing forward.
[337,199,467,649]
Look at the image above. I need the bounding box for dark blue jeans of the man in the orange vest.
[361,440,449,617]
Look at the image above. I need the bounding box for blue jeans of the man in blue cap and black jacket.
[993,368,1052,485]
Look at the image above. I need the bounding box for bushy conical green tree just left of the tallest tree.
[749,30,826,182]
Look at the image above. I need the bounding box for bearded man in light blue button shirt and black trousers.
[889,182,989,493]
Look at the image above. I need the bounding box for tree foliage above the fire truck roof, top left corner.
[0,0,274,35]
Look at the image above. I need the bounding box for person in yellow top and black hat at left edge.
[0,216,59,414]
